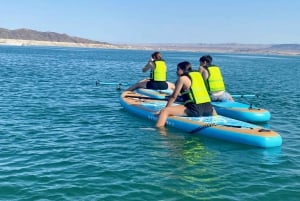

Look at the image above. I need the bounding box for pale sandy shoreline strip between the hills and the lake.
[0,39,300,56]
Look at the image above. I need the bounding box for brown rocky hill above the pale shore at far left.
[0,28,109,44]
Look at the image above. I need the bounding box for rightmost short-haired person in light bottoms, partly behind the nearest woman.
[199,55,234,101]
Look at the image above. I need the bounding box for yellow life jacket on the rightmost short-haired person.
[207,66,225,92]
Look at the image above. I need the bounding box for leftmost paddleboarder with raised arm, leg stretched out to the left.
[126,52,175,91]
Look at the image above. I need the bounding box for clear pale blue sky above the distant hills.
[0,0,300,44]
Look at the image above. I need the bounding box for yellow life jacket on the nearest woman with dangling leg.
[182,71,211,104]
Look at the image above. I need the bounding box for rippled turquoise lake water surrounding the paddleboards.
[0,46,300,201]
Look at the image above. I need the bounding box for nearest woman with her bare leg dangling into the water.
[156,61,217,128]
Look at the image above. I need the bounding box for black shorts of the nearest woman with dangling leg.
[185,103,213,117]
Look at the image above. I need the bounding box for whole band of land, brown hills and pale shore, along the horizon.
[0,28,300,55]
